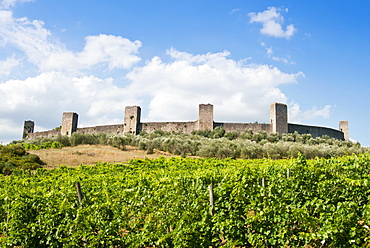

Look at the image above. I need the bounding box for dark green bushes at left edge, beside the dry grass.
[0,144,42,175]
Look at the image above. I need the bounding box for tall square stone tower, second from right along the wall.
[270,103,288,133]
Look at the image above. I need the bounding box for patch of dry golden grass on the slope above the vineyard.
[28,145,173,169]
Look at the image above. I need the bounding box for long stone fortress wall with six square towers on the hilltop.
[22,103,349,140]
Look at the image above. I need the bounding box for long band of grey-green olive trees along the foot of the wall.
[22,126,370,159]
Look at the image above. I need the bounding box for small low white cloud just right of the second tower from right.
[289,103,331,123]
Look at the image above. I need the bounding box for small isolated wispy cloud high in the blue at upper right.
[248,7,297,39]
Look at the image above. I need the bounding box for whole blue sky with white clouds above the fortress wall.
[0,0,370,146]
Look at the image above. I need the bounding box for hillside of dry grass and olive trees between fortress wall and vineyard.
[10,128,369,168]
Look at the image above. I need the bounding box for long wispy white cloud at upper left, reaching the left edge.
[0,10,141,71]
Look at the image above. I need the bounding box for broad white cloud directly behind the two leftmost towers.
[0,72,139,132]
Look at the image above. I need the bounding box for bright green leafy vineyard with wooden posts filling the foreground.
[0,154,370,247]
